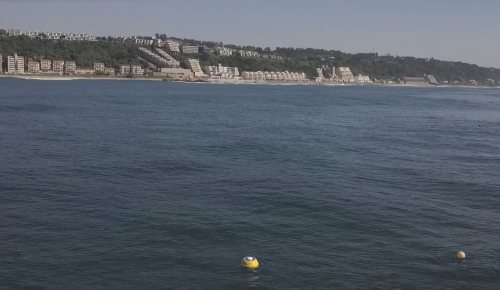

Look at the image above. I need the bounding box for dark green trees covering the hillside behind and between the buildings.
[0,34,500,84]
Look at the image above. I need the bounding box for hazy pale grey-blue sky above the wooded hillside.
[0,0,500,68]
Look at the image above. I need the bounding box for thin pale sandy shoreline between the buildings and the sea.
[0,74,500,89]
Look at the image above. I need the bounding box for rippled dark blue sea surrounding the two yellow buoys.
[0,79,500,289]
